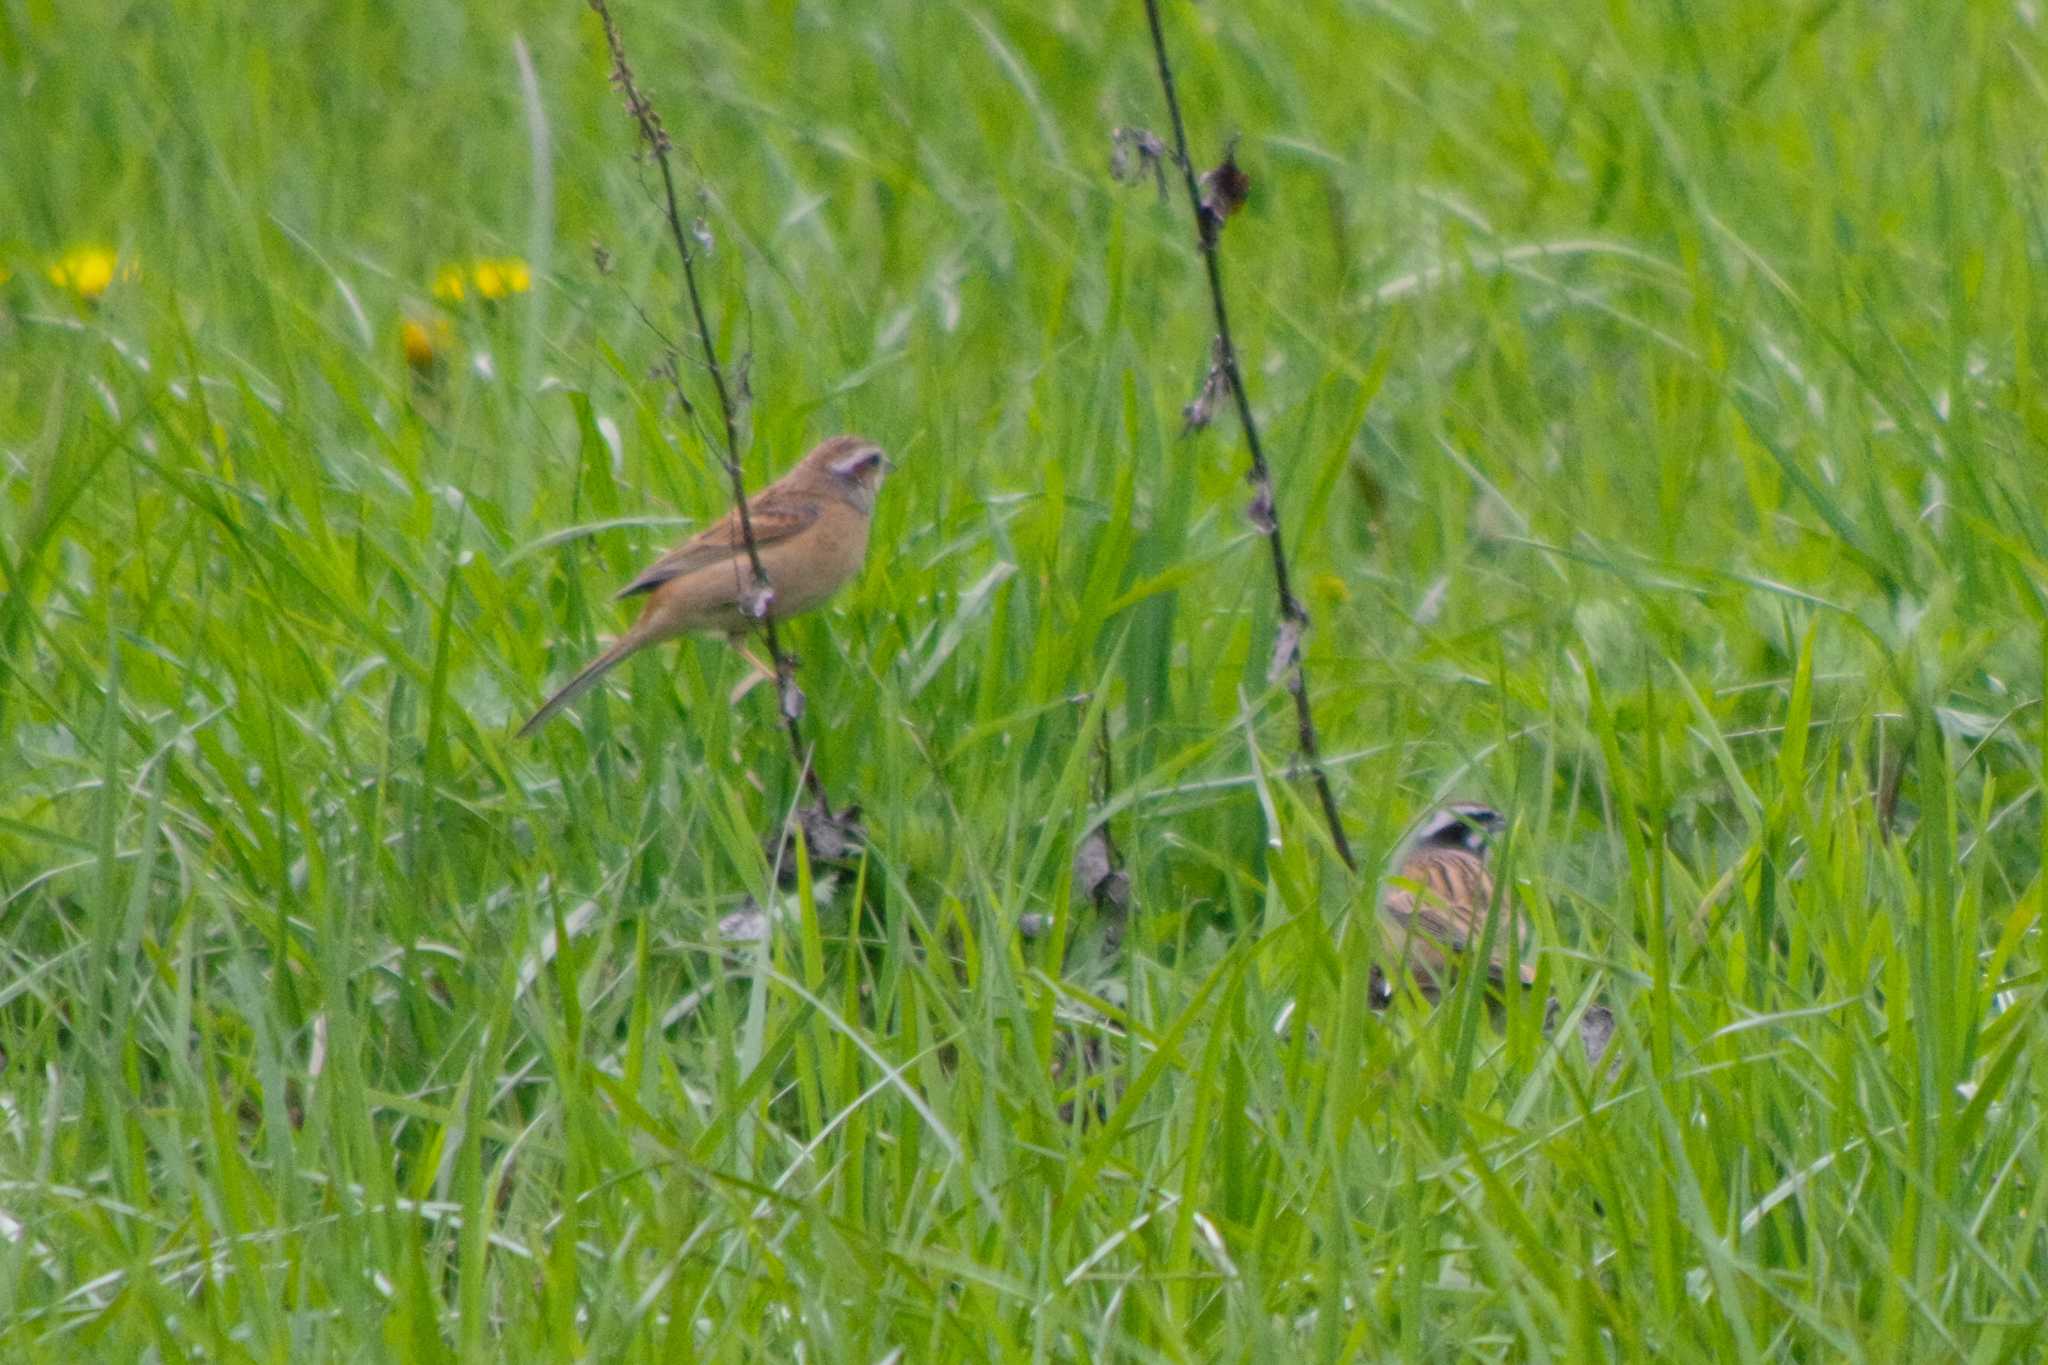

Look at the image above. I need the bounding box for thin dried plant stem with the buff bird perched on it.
[590,0,831,812]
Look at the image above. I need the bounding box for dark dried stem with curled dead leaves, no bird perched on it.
[1145,0,1358,872]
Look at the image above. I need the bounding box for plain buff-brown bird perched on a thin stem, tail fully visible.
[518,436,893,739]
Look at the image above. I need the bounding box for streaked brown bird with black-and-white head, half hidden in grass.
[1374,802,1536,1003]
